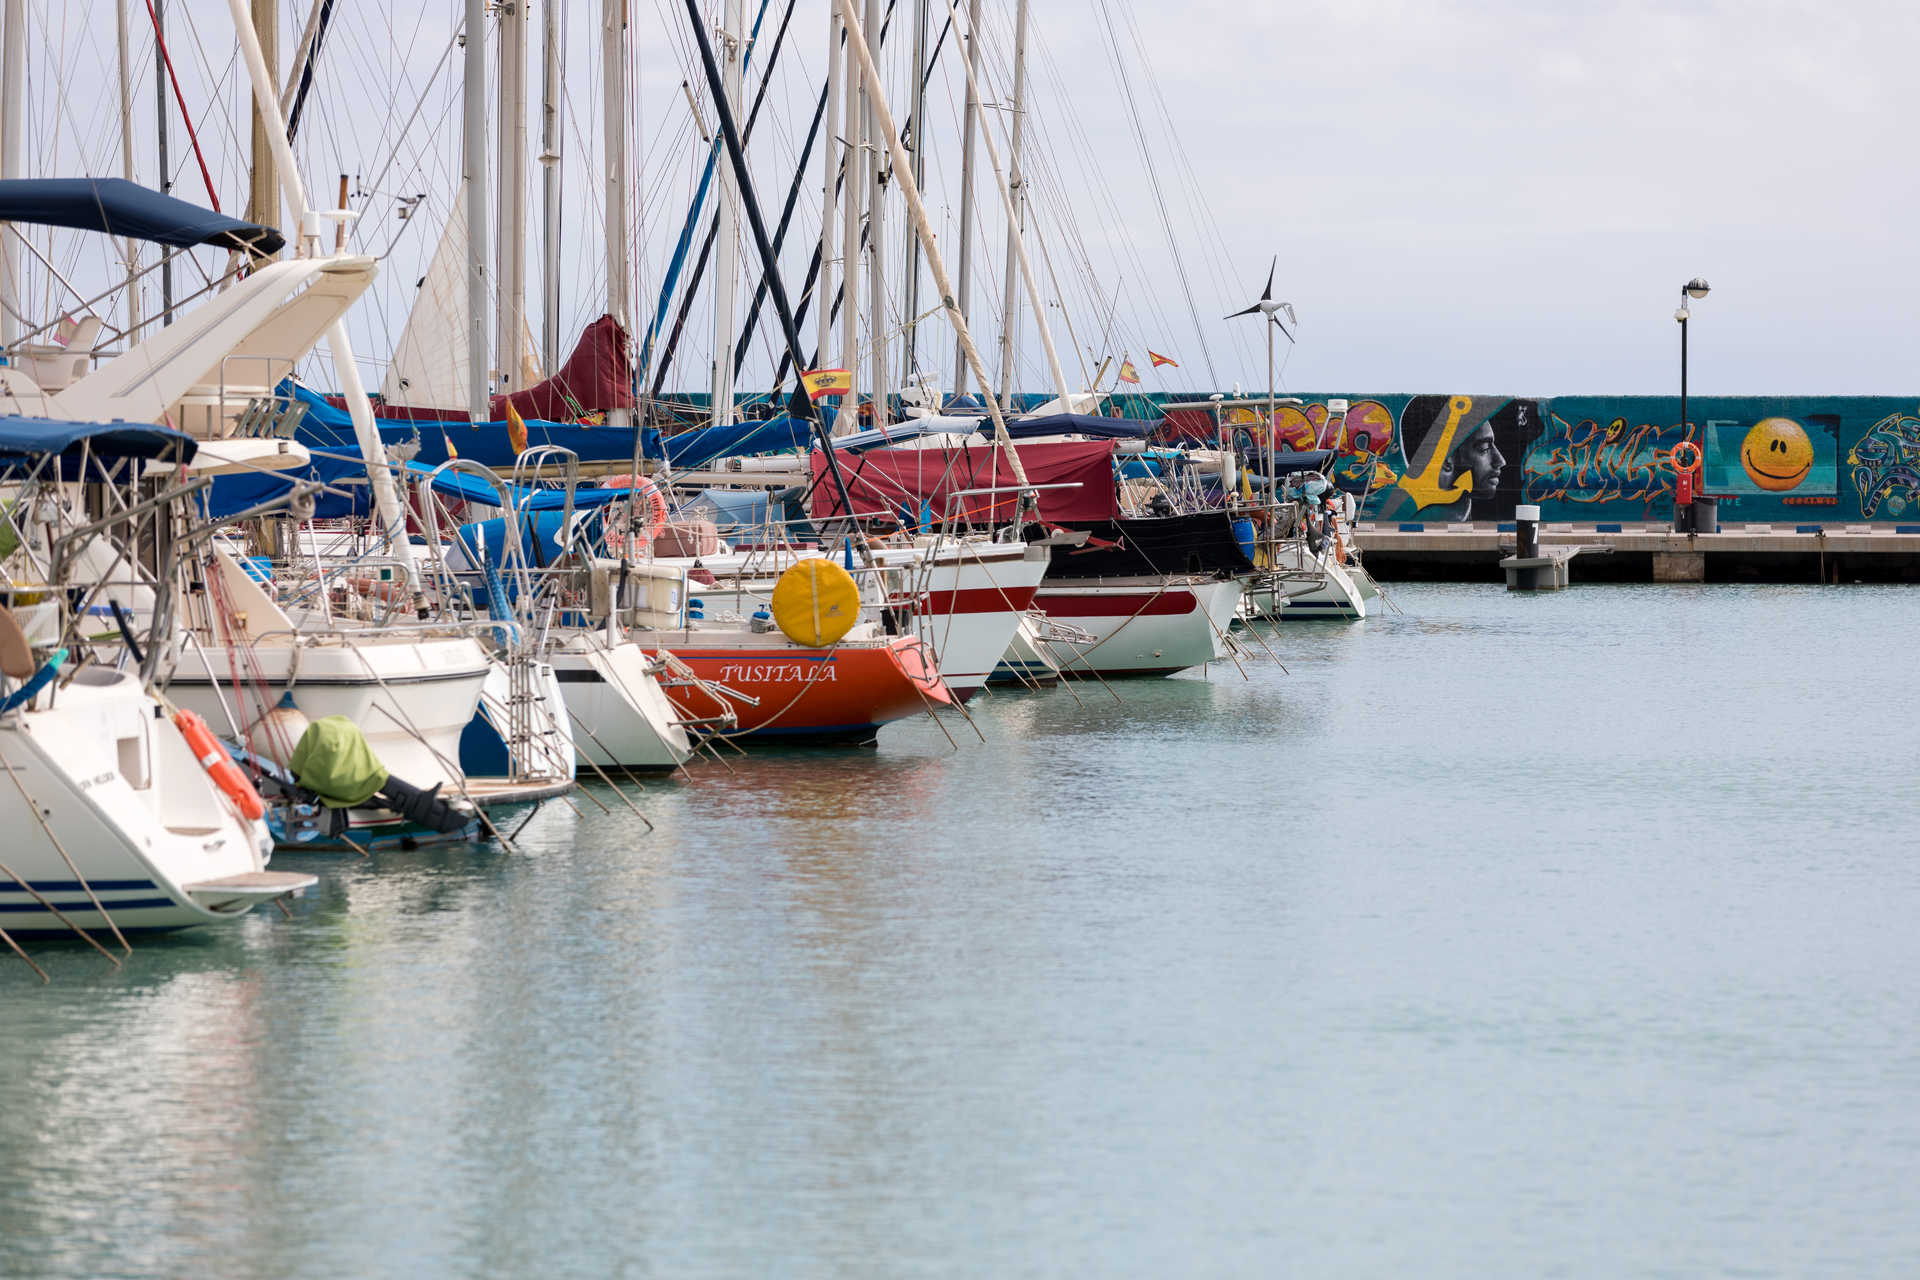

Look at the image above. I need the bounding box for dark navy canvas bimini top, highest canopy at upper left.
[0,178,286,253]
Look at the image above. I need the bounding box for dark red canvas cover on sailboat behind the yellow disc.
[812,439,1119,524]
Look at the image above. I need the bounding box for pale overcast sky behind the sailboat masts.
[15,0,1920,393]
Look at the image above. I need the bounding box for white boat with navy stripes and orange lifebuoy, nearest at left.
[0,415,315,938]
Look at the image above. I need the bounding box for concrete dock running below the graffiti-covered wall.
[1354,520,1920,587]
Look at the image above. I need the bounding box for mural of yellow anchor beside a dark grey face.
[1379,395,1540,520]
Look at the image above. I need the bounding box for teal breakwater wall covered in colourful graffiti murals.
[1123,393,1920,533]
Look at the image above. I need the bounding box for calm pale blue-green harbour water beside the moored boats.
[0,585,1920,1276]
